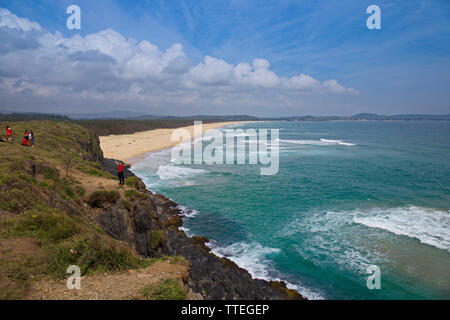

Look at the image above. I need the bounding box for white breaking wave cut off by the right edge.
[353,206,450,252]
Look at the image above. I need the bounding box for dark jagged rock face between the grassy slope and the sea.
[100,159,304,300]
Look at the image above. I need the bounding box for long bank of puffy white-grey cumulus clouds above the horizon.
[0,8,358,113]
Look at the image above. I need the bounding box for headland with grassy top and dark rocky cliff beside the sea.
[0,121,302,299]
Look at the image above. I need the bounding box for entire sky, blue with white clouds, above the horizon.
[0,0,450,116]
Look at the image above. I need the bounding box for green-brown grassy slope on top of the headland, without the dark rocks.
[0,121,185,299]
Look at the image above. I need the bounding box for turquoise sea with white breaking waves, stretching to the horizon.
[132,121,450,299]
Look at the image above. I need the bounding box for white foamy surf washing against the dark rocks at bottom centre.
[206,240,324,300]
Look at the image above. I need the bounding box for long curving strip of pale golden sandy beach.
[100,121,250,163]
